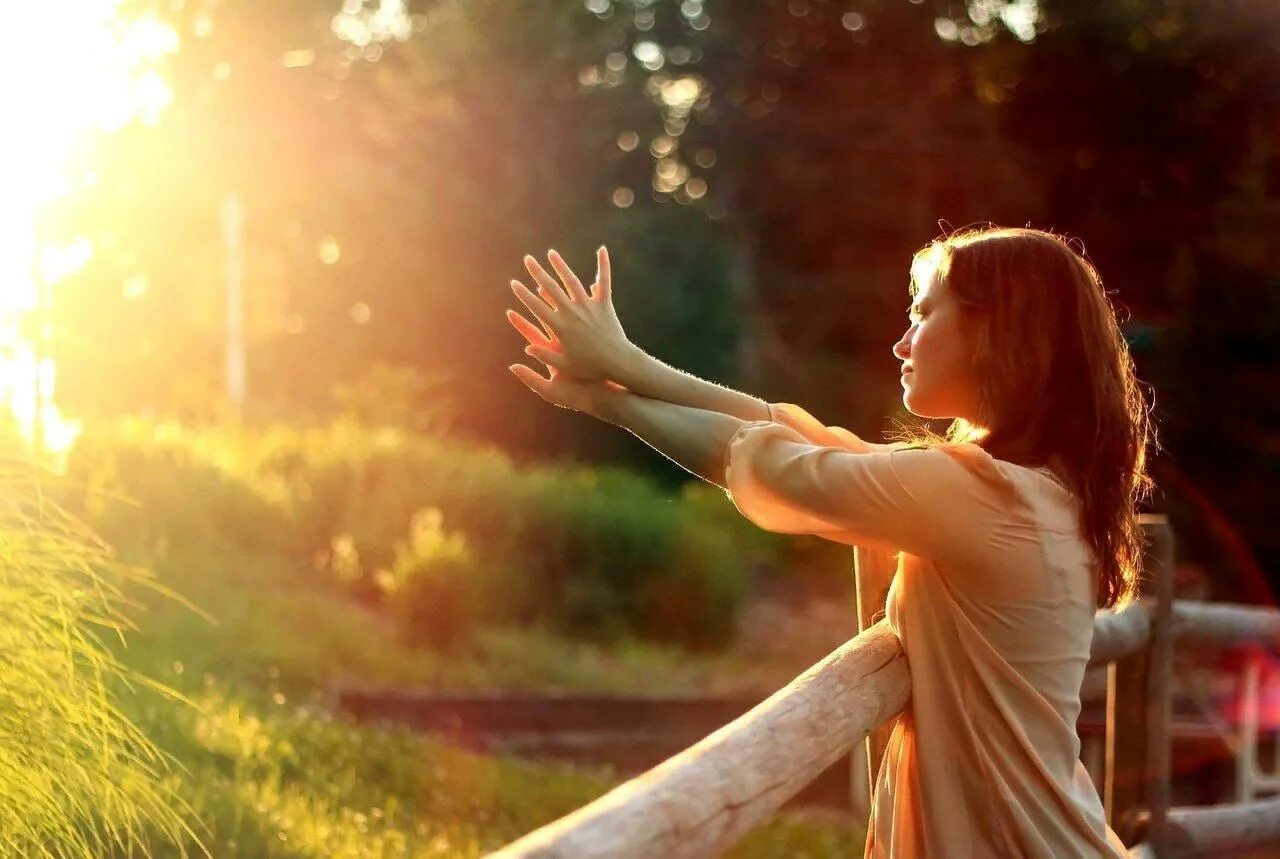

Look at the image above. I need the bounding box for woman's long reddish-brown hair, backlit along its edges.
[910,227,1158,608]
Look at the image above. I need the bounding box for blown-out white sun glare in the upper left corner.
[0,0,178,452]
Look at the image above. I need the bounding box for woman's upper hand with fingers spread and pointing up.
[507,247,635,390]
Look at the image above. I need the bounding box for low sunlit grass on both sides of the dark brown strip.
[104,547,863,858]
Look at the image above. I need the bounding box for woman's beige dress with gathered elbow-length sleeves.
[726,403,1126,859]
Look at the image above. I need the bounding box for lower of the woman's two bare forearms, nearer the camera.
[591,388,747,489]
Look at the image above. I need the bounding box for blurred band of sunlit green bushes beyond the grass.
[72,421,781,646]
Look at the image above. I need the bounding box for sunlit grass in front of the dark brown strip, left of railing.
[115,682,863,859]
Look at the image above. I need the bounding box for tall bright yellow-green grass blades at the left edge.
[0,450,200,856]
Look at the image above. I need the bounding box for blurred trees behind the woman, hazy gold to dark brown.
[35,0,1280,598]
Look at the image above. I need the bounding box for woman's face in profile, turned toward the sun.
[893,275,979,424]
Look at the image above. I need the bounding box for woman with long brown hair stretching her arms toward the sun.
[508,228,1155,856]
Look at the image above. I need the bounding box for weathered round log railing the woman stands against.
[494,516,1280,859]
